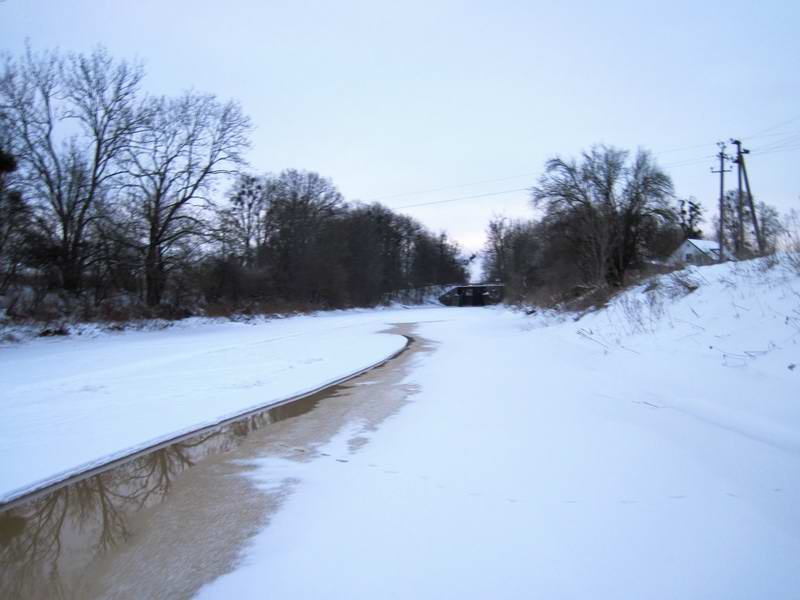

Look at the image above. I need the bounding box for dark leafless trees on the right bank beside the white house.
[484,146,782,305]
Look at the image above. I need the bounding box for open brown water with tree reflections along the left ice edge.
[0,413,270,598]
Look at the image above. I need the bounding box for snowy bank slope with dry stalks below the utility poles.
[576,259,800,452]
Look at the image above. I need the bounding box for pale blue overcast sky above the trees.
[0,0,800,249]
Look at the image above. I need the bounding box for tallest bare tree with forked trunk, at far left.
[0,48,143,291]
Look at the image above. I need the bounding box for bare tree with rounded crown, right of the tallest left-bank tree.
[125,92,250,306]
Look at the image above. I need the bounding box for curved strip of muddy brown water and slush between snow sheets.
[0,324,433,599]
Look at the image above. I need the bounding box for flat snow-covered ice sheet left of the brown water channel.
[0,310,424,502]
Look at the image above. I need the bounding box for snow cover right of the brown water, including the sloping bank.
[195,262,800,599]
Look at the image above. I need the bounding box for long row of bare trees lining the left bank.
[0,49,465,318]
